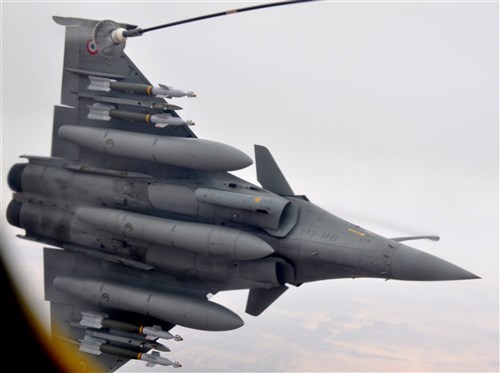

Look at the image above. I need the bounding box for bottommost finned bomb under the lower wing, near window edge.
[80,335,182,368]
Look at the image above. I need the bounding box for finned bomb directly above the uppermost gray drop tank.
[87,103,194,128]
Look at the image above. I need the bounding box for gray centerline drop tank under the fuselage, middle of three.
[75,207,274,260]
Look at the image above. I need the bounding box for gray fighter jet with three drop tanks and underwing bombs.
[6,2,478,371]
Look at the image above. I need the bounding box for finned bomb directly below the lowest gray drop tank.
[80,311,183,342]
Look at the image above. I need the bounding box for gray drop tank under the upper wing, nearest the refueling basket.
[58,125,253,171]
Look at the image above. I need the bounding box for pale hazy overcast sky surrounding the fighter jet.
[1,1,499,372]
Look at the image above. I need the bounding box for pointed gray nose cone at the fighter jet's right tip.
[392,246,480,281]
